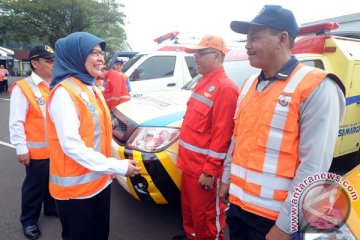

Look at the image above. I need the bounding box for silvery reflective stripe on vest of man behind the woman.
[25,77,48,148]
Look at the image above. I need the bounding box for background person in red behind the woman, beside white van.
[103,59,130,110]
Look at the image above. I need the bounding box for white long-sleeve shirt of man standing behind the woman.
[9,72,47,155]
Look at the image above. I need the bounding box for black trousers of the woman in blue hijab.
[55,185,110,240]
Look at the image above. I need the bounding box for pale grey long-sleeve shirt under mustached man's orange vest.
[222,78,345,234]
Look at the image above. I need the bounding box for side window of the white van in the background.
[130,56,176,81]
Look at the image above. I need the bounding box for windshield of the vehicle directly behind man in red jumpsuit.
[182,60,260,90]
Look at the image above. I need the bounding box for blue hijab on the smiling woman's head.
[50,32,106,89]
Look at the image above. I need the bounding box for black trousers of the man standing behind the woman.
[20,159,56,226]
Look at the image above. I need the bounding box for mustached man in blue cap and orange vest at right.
[220,5,345,240]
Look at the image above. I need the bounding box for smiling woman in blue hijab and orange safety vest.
[47,32,140,240]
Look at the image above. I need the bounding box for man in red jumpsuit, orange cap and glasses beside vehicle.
[173,35,238,239]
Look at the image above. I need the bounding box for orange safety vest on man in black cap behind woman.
[10,77,50,160]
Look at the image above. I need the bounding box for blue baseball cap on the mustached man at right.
[230,5,299,39]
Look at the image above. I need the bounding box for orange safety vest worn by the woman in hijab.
[47,77,112,199]
